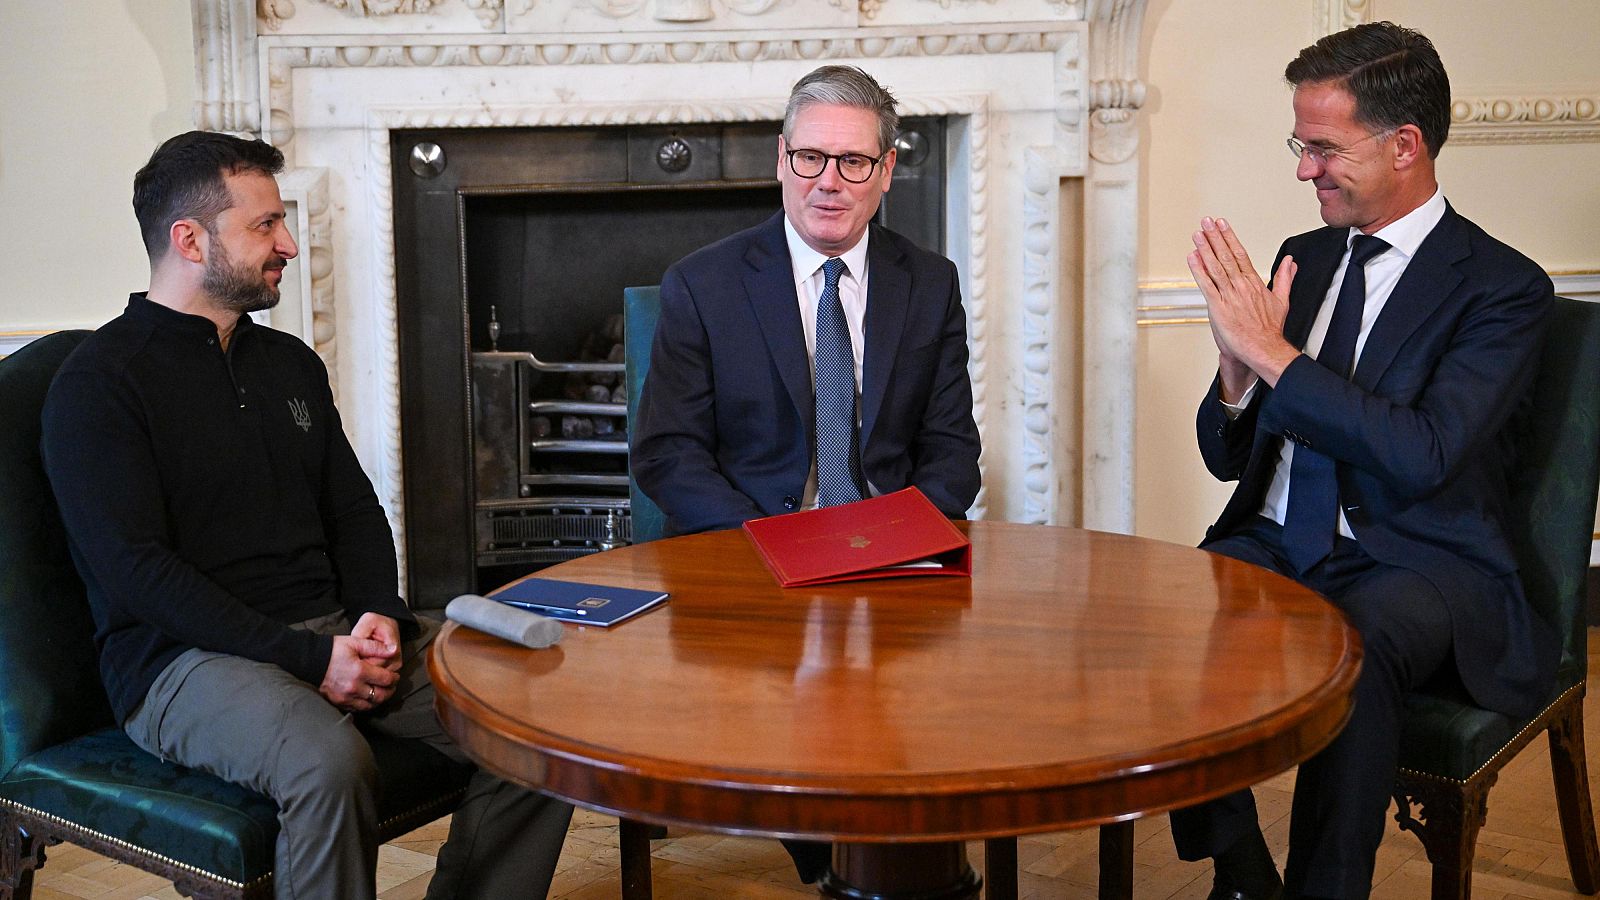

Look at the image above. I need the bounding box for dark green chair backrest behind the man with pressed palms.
[1510,298,1600,689]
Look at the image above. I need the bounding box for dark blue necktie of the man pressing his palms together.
[1283,234,1389,573]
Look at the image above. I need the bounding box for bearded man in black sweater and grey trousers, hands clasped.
[43,131,571,898]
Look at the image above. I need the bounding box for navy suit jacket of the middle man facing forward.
[630,213,979,535]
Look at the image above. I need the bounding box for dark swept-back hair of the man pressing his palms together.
[1283,22,1450,157]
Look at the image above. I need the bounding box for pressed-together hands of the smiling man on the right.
[1189,218,1299,392]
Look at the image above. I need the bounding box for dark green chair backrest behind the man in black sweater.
[0,331,112,777]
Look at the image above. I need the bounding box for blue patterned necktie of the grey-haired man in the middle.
[816,258,861,506]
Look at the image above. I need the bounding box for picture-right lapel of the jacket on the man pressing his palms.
[1352,207,1470,391]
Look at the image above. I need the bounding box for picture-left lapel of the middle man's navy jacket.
[744,213,814,421]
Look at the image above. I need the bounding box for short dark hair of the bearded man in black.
[133,131,283,259]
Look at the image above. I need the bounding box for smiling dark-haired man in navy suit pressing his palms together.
[1171,22,1558,898]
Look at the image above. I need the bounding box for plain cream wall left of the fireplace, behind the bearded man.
[0,0,194,331]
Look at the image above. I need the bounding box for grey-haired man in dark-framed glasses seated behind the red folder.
[630,66,979,533]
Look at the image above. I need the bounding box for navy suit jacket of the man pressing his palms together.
[1197,208,1560,714]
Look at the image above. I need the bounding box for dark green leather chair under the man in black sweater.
[0,331,469,900]
